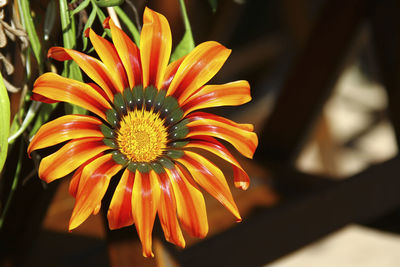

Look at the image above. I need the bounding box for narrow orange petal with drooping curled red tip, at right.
[185,136,250,190]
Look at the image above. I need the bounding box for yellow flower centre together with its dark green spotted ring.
[101,86,188,170]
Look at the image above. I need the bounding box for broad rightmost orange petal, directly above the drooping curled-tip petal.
[187,112,258,158]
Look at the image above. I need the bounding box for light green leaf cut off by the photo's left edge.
[0,73,10,172]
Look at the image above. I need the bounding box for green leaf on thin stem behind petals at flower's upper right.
[170,0,194,62]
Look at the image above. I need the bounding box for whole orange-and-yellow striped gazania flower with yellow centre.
[28,8,258,256]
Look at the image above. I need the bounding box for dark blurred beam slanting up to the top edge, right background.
[257,0,369,163]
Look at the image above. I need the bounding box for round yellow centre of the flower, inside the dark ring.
[117,110,168,162]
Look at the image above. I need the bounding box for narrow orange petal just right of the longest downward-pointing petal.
[158,172,185,248]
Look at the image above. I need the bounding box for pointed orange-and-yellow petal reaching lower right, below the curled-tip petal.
[176,151,242,221]
